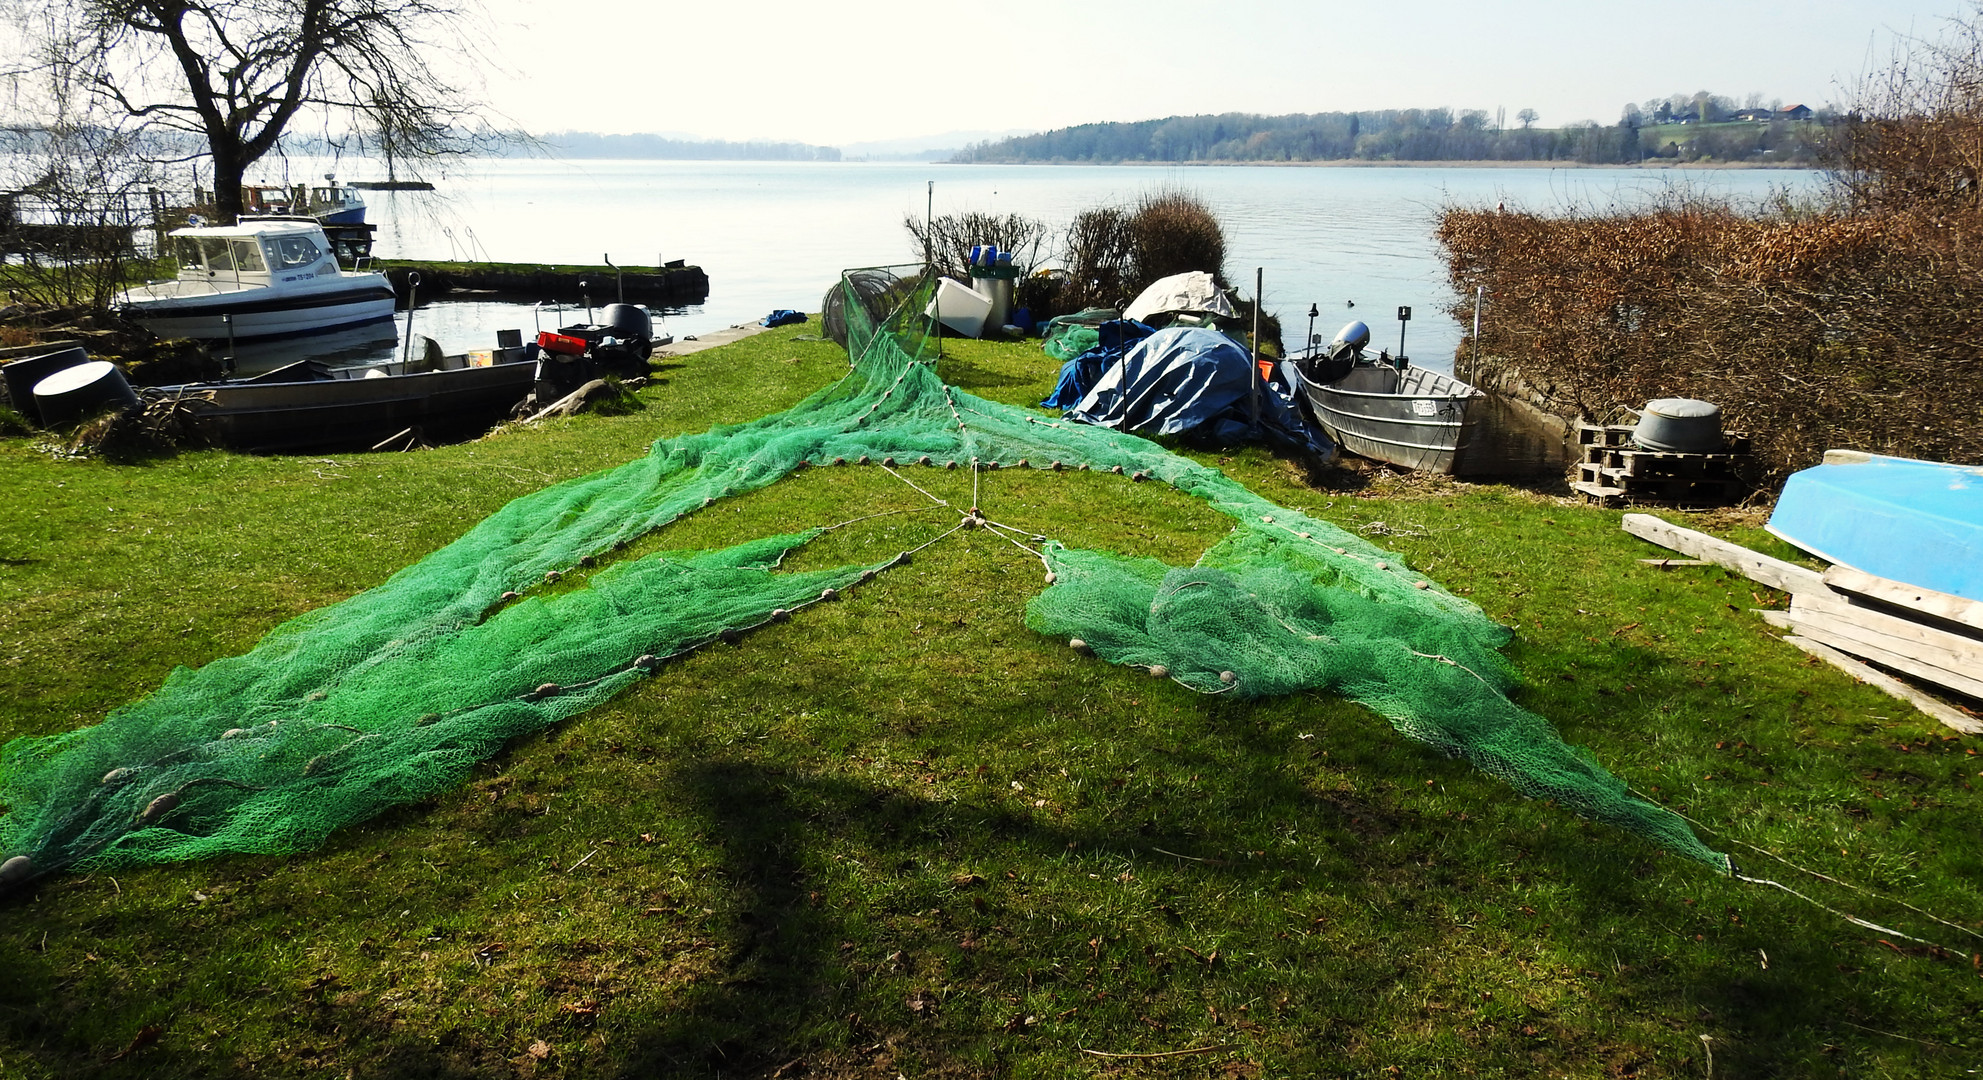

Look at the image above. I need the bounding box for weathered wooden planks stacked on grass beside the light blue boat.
[1624,513,1983,735]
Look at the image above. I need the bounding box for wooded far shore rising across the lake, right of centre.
[952,109,1824,164]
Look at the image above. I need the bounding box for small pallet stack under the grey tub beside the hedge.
[1571,424,1755,505]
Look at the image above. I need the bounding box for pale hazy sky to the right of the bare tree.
[486,0,1973,145]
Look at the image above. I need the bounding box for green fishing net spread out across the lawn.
[0,271,1729,884]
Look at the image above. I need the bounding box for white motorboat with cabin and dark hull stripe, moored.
[117,218,393,341]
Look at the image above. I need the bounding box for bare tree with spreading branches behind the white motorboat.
[0,0,493,220]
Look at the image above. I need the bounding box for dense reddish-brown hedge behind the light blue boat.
[1438,14,1983,478]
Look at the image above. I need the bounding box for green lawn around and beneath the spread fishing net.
[0,325,1983,1078]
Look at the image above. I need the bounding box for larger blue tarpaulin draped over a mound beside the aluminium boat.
[1065,323,1335,451]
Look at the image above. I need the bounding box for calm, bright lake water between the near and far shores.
[293,159,1822,369]
